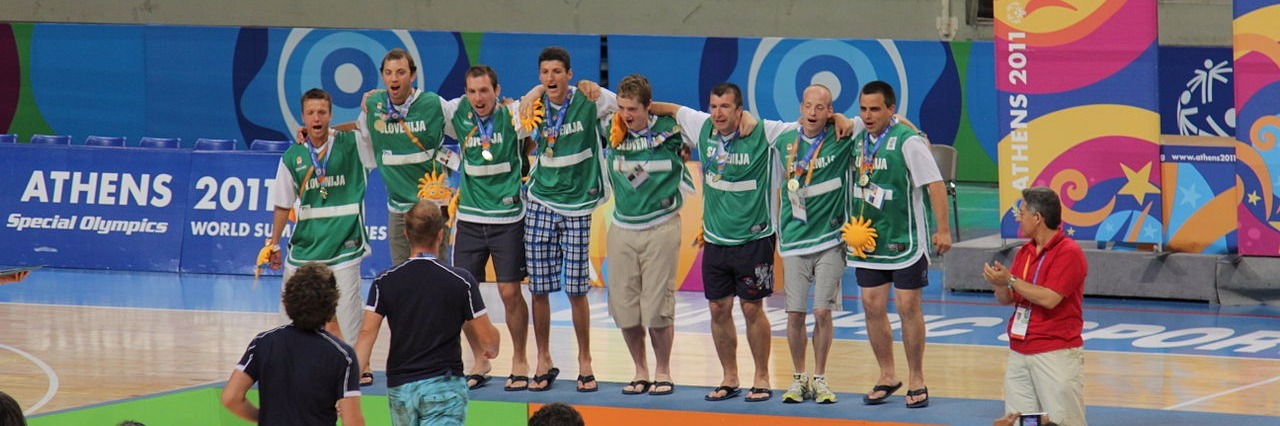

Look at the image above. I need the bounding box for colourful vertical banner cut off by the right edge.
[1231,0,1280,256]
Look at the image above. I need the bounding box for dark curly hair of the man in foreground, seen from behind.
[280,262,338,331]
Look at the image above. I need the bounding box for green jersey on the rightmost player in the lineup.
[847,124,928,270]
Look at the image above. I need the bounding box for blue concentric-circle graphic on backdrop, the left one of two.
[276,28,422,130]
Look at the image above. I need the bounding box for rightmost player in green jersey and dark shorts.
[847,81,951,408]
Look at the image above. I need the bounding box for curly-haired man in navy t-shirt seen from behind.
[223,262,365,426]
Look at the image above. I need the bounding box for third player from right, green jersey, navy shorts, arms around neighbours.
[652,83,786,402]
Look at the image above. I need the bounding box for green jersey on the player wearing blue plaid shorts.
[529,91,604,216]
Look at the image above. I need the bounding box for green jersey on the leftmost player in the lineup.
[280,132,369,266]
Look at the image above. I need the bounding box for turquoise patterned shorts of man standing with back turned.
[387,375,467,426]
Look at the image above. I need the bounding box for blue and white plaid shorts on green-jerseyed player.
[525,202,591,296]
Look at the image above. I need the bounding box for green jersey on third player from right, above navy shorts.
[698,119,774,246]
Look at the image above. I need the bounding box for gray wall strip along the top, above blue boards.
[0,0,1231,46]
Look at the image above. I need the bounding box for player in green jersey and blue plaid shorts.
[525,46,617,391]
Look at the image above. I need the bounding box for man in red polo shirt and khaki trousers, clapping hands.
[983,187,1088,425]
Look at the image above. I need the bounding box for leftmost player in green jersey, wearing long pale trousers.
[268,88,372,344]
